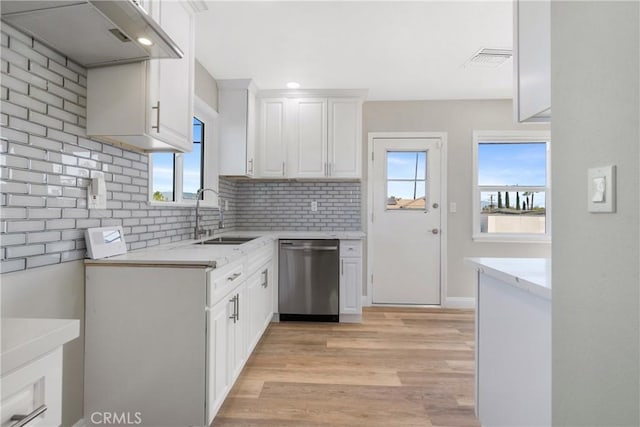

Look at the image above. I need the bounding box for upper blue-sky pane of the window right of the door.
[478,142,547,187]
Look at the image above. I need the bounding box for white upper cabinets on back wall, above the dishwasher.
[257,91,363,179]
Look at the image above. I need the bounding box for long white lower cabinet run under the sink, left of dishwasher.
[85,245,273,426]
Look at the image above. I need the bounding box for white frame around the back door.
[364,131,449,307]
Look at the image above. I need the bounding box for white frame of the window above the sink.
[147,96,219,208]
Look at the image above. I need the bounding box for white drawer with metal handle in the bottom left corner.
[0,347,62,427]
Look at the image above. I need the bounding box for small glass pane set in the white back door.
[387,151,427,210]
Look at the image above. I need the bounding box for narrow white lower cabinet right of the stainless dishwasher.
[340,240,362,323]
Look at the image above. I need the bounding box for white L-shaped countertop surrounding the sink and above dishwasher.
[85,230,364,268]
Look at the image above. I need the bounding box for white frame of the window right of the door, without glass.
[471,130,552,243]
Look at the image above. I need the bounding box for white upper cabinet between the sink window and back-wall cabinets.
[218,79,256,176]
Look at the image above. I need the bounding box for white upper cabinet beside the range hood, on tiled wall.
[87,0,194,152]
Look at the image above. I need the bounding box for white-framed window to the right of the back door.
[473,131,551,242]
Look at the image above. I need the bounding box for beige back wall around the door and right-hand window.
[362,100,553,298]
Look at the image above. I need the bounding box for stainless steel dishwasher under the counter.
[278,240,340,322]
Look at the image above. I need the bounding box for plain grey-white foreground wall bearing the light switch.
[551,1,640,426]
